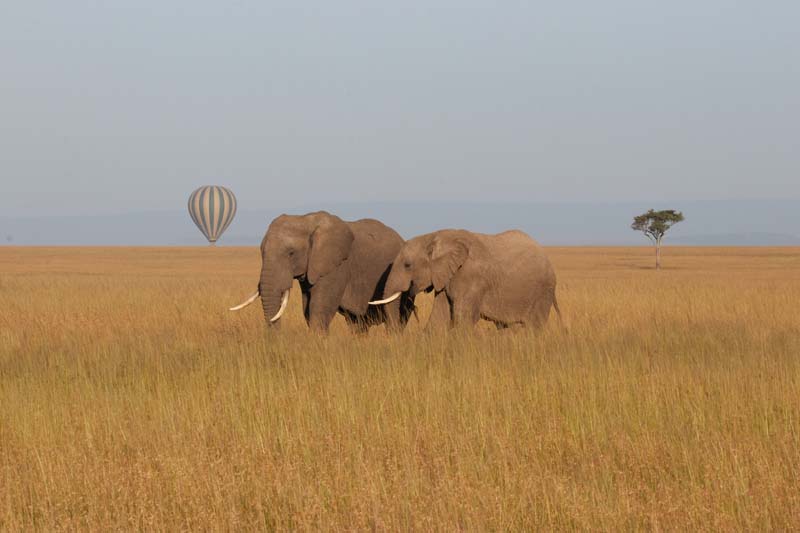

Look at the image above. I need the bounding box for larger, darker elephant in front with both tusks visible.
[231,211,414,332]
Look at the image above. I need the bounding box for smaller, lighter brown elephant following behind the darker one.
[370,230,561,329]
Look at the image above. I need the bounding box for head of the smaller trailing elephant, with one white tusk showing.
[370,231,469,305]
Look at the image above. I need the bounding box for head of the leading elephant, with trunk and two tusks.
[231,211,354,324]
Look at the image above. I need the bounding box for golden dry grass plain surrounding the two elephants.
[0,247,800,531]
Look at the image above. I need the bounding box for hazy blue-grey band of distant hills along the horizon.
[0,200,800,246]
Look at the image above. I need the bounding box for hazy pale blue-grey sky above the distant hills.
[0,0,800,216]
